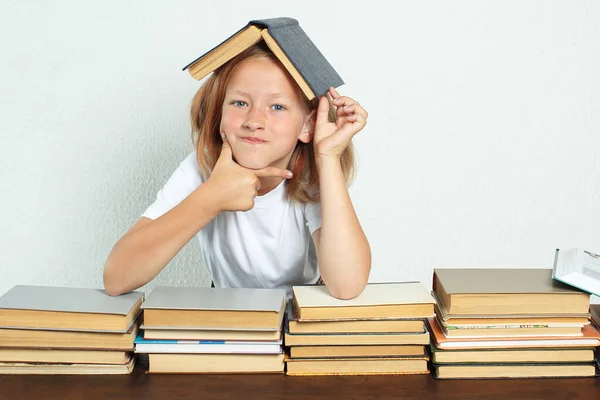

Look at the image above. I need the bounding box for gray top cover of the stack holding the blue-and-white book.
[142,286,285,312]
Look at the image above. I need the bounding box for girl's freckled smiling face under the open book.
[220,58,314,169]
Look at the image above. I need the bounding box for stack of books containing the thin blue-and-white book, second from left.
[135,287,285,373]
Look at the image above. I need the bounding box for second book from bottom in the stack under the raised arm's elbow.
[289,344,427,358]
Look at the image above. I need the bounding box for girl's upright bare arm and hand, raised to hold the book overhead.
[313,87,371,299]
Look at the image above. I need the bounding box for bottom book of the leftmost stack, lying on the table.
[0,357,135,375]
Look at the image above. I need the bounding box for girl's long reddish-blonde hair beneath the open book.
[190,43,355,204]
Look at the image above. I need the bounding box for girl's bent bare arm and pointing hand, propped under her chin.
[104,141,291,295]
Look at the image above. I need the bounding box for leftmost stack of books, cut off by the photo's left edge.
[0,285,143,374]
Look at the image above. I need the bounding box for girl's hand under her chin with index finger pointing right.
[205,139,292,211]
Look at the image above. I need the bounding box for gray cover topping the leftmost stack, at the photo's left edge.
[0,285,144,315]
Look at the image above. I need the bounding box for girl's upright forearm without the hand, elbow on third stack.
[318,158,371,298]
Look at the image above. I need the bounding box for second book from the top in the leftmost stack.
[0,324,138,351]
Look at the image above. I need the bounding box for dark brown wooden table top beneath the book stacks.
[0,363,600,400]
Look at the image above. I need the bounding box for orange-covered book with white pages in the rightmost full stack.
[427,318,600,350]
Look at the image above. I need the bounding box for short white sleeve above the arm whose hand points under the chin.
[142,151,204,219]
